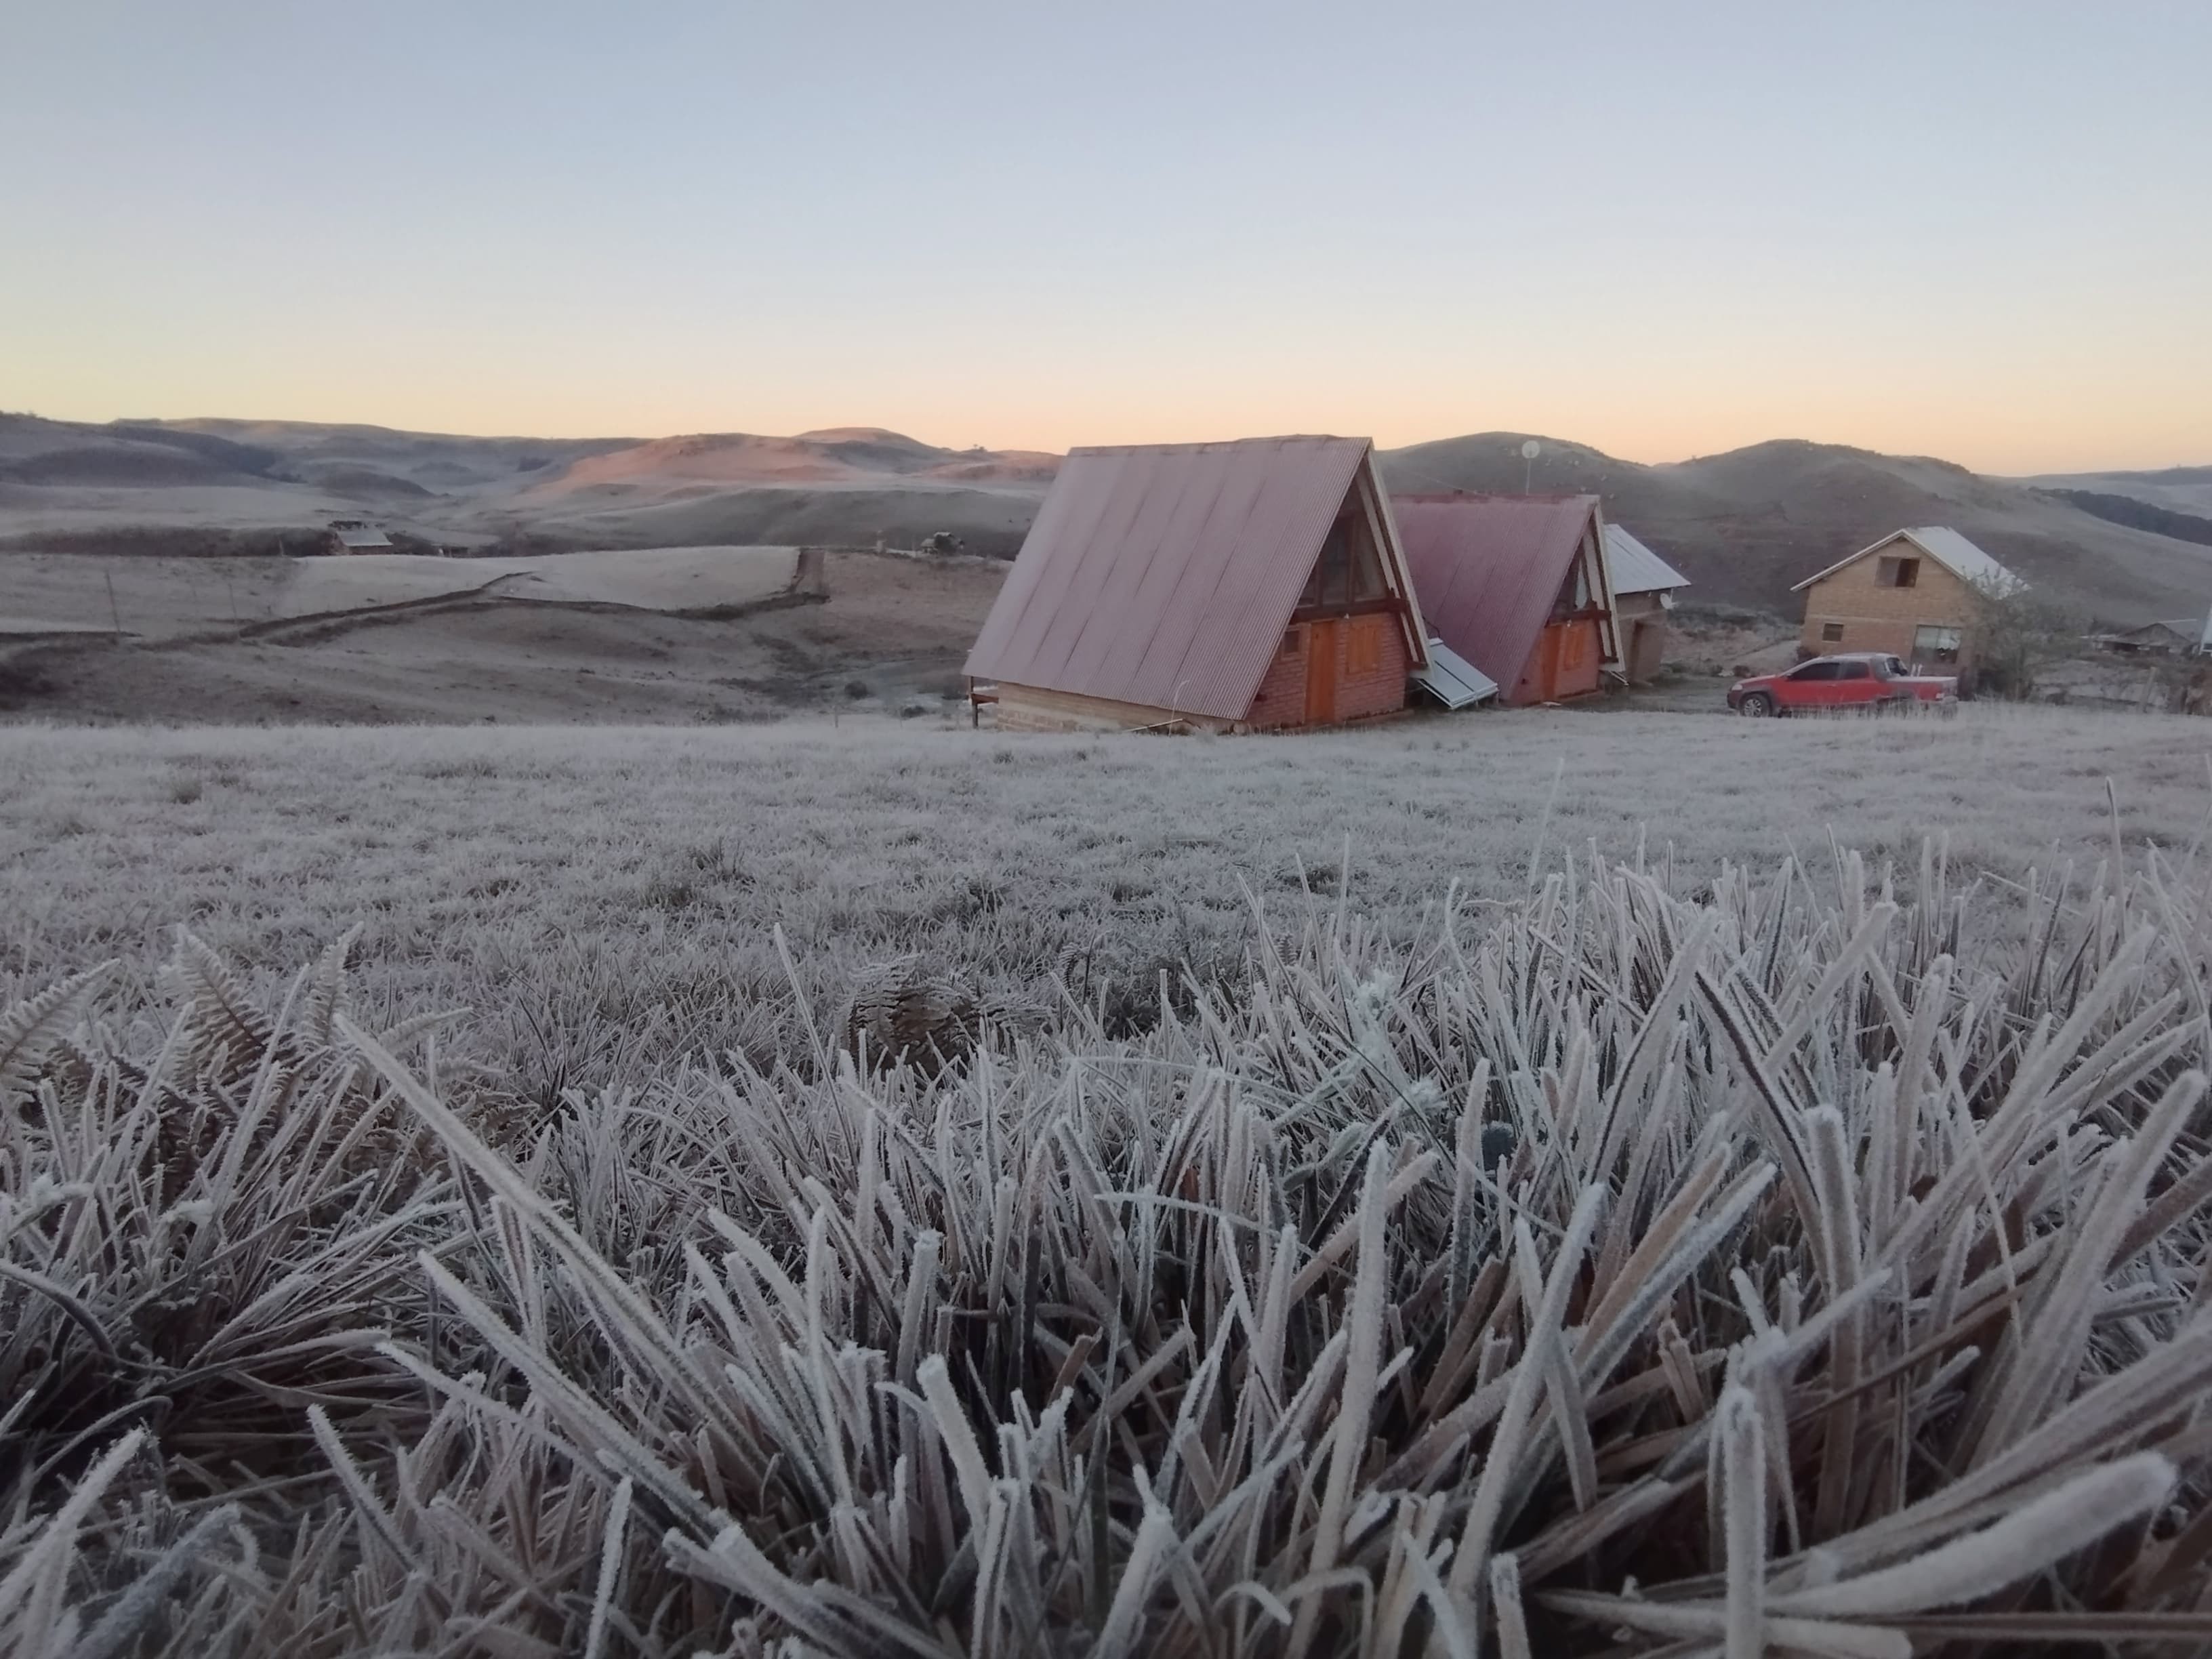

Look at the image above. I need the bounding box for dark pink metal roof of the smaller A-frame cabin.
[1389,495,1597,697]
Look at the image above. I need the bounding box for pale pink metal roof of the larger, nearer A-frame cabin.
[966,438,1369,719]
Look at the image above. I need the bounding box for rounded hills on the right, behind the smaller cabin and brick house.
[1380,431,2212,621]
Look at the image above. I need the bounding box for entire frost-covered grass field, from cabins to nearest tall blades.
[13,710,2212,1659]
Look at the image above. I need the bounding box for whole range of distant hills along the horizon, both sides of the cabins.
[0,416,2212,621]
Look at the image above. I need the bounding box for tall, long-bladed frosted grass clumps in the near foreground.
[0,836,2212,1659]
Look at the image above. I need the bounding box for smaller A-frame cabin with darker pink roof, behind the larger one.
[1391,495,1619,703]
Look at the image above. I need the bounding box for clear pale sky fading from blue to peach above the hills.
[0,0,2212,471]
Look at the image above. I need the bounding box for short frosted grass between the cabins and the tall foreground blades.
[0,708,2212,1099]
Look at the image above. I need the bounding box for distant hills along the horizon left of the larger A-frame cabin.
[0,416,1059,558]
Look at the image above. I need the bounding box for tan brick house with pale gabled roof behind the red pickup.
[1790,525,2022,668]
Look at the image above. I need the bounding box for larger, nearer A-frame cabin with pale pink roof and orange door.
[966,438,1429,732]
